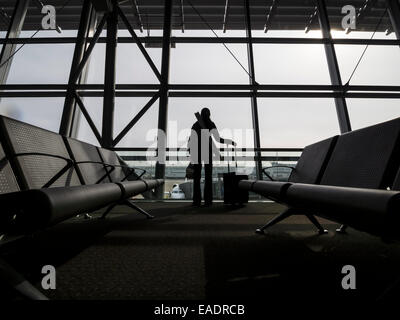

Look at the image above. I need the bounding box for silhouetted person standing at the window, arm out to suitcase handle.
[189,108,236,206]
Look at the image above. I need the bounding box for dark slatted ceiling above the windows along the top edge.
[0,0,390,31]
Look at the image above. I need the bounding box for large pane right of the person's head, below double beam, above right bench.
[258,98,339,148]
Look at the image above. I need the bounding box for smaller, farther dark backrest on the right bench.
[289,136,338,184]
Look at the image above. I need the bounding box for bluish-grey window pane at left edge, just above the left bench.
[0,98,64,132]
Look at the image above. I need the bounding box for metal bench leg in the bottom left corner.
[0,260,48,300]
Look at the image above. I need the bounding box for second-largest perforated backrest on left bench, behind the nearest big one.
[64,138,110,184]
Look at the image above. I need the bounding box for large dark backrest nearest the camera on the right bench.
[321,118,400,189]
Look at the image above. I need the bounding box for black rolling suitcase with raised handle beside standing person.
[223,148,249,205]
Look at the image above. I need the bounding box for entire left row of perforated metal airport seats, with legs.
[0,116,163,299]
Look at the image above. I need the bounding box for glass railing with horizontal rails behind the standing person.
[116,148,302,200]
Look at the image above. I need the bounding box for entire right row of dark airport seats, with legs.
[239,118,400,238]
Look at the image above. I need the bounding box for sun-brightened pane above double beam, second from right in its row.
[254,44,331,84]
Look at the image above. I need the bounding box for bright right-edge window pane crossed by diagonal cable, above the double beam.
[335,45,400,85]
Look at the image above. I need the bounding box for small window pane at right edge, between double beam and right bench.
[346,99,400,130]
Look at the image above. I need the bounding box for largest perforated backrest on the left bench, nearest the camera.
[0,116,81,190]
